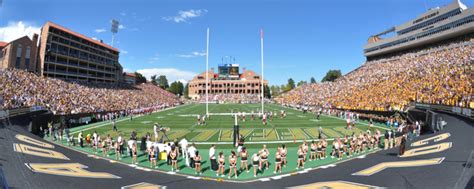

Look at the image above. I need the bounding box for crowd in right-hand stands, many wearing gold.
[277,41,474,111]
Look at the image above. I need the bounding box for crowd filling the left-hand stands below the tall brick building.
[0,69,179,114]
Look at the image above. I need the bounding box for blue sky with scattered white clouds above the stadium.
[0,0,474,85]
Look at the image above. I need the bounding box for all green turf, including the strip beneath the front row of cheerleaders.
[58,104,384,181]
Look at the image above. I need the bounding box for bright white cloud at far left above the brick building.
[0,21,41,42]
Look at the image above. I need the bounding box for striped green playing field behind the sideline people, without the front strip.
[73,104,386,144]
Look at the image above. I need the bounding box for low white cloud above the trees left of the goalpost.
[137,68,197,83]
